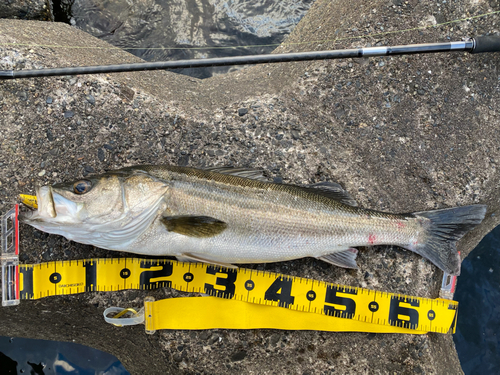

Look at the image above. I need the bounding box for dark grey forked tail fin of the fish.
[409,205,486,276]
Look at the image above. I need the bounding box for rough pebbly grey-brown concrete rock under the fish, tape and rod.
[0,0,500,374]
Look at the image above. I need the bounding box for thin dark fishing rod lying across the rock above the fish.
[0,36,500,80]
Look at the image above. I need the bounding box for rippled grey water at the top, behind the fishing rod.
[54,0,314,78]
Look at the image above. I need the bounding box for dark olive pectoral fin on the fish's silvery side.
[160,216,227,238]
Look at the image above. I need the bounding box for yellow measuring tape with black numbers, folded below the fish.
[19,258,458,334]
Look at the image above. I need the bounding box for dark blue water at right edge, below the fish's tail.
[453,226,500,375]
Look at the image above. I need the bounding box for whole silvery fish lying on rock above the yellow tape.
[19,165,486,275]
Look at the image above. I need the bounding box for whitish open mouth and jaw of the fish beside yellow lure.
[19,186,78,222]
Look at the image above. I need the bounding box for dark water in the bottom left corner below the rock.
[0,338,129,375]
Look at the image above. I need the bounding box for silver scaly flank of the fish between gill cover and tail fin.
[130,171,419,263]
